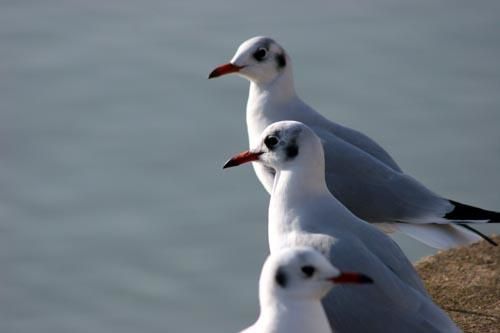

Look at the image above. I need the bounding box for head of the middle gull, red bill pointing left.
[223,120,324,170]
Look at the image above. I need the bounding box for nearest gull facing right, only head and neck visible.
[241,247,373,333]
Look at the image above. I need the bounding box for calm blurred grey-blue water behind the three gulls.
[0,0,500,333]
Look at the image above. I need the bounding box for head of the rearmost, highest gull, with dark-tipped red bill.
[208,36,290,84]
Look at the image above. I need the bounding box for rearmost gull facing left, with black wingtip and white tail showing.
[209,37,500,249]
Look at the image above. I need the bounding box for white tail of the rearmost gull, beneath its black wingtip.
[393,223,486,250]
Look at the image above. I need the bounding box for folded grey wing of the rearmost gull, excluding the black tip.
[313,128,452,223]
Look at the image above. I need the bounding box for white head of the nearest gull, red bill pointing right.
[259,247,373,302]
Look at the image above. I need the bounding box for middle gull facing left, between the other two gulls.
[224,121,460,333]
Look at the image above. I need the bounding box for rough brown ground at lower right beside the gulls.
[415,236,500,333]
